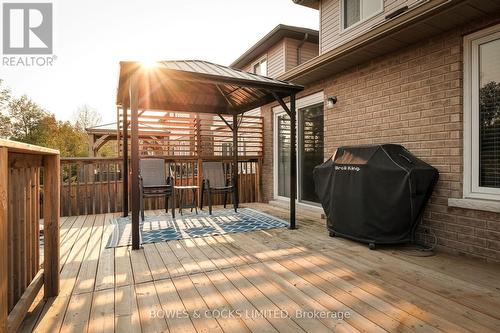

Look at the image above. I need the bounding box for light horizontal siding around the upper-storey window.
[320,0,418,53]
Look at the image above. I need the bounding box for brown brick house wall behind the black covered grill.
[262,15,500,261]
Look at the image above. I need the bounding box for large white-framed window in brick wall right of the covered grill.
[464,25,500,200]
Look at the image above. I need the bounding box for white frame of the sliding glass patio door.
[272,91,325,207]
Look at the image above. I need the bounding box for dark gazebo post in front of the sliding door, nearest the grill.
[289,94,297,229]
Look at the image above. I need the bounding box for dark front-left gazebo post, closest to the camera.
[129,74,141,250]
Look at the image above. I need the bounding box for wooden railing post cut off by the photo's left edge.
[0,147,9,333]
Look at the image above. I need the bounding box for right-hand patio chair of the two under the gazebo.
[200,162,238,215]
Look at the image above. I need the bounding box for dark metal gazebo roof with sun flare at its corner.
[116,60,304,114]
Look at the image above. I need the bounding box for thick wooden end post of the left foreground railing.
[43,155,60,298]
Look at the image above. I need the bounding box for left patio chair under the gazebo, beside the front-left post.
[139,159,175,221]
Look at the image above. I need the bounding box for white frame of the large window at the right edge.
[463,24,500,201]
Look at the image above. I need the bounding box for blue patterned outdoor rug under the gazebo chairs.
[106,208,288,247]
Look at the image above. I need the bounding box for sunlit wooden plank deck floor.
[22,205,500,333]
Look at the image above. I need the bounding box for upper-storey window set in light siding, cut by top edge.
[342,0,384,29]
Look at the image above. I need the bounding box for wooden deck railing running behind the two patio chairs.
[61,156,261,216]
